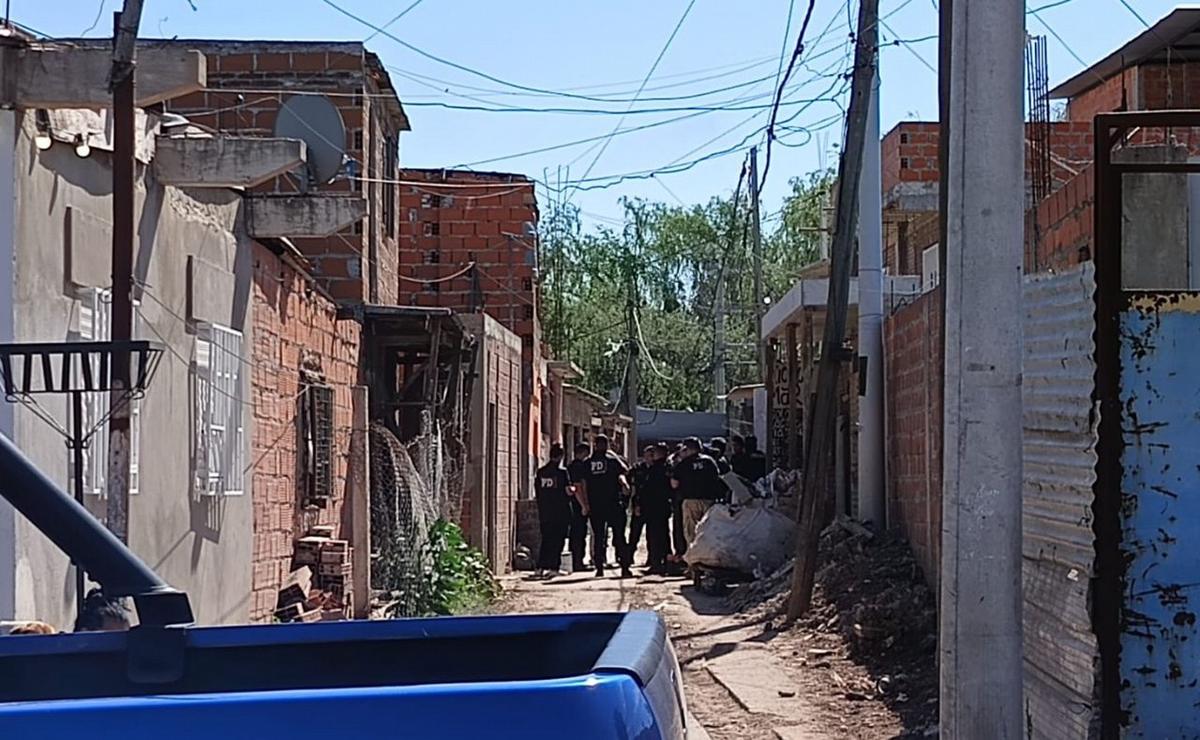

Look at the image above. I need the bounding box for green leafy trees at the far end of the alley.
[541,172,833,410]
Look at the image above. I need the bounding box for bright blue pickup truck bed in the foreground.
[0,613,686,740]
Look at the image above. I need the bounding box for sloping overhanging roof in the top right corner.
[1050,5,1200,98]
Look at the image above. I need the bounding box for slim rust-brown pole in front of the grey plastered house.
[107,0,142,542]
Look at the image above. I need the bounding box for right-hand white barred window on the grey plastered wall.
[192,323,246,495]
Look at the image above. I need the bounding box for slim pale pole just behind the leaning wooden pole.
[858,72,887,530]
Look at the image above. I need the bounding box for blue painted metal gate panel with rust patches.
[1120,293,1200,738]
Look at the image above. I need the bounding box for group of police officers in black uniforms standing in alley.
[535,434,767,578]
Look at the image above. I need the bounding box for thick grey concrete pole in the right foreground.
[938,0,1025,740]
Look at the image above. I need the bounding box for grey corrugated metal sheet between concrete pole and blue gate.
[1021,263,1099,740]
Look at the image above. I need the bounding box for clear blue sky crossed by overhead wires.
[11,0,1177,223]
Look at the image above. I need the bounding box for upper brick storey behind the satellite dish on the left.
[167,41,407,303]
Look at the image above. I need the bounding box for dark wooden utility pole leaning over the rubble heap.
[787,0,880,621]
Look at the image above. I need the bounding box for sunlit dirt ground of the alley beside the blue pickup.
[498,549,926,740]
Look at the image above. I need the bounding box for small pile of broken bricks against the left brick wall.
[275,527,353,621]
